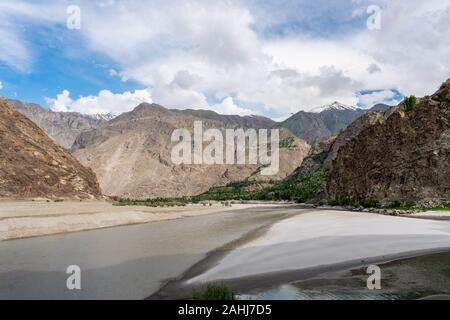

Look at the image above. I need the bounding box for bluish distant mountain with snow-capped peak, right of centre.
[276,102,367,144]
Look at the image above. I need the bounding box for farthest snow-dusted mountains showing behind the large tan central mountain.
[7,100,389,149]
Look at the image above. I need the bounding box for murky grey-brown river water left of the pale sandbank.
[0,208,302,299]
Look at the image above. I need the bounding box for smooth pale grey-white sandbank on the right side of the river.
[187,210,450,284]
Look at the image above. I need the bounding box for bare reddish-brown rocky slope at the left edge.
[0,99,101,198]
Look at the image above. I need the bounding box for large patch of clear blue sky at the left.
[0,20,144,107]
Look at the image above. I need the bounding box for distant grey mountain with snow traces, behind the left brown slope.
[7,100,107,149]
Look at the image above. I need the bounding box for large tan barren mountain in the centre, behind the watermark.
[71,103,309,199]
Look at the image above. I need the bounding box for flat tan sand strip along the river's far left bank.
[0,201,286,240]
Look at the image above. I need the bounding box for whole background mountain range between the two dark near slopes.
[0,96,394,199]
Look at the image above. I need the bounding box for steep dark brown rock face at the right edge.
[327,85,450,202]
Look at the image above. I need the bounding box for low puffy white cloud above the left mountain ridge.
[46,90,152,115]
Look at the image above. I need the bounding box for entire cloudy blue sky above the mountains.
[0,0,450,119]
